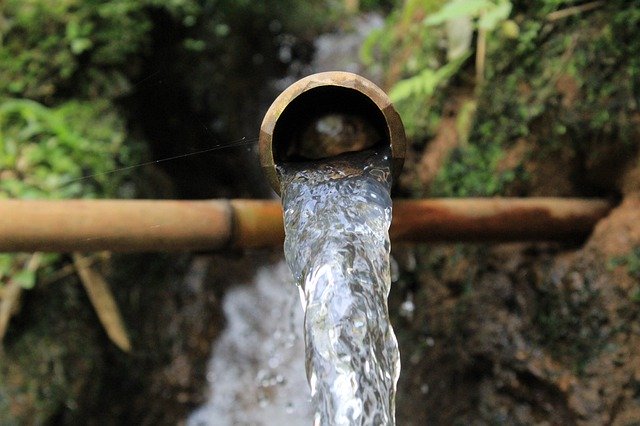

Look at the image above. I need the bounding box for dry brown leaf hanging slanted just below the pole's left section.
[73,253,131,352]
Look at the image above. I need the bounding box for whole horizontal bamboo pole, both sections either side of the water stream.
[0,198,611,252]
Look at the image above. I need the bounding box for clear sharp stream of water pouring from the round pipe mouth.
[279,151,400,425]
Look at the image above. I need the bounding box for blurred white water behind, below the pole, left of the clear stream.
[187,262,313,426]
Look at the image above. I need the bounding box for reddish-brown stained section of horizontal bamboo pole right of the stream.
[390,198,611,242]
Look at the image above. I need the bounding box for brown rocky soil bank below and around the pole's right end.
[390,154,640,426]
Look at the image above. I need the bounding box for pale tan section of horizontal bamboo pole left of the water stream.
[0,200,283,252]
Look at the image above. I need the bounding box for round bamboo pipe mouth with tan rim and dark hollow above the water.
[258,71,406,194]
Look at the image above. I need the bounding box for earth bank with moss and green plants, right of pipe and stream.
[370,0,640,425]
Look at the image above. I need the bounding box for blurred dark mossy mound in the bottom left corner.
[0,282,103,424]
